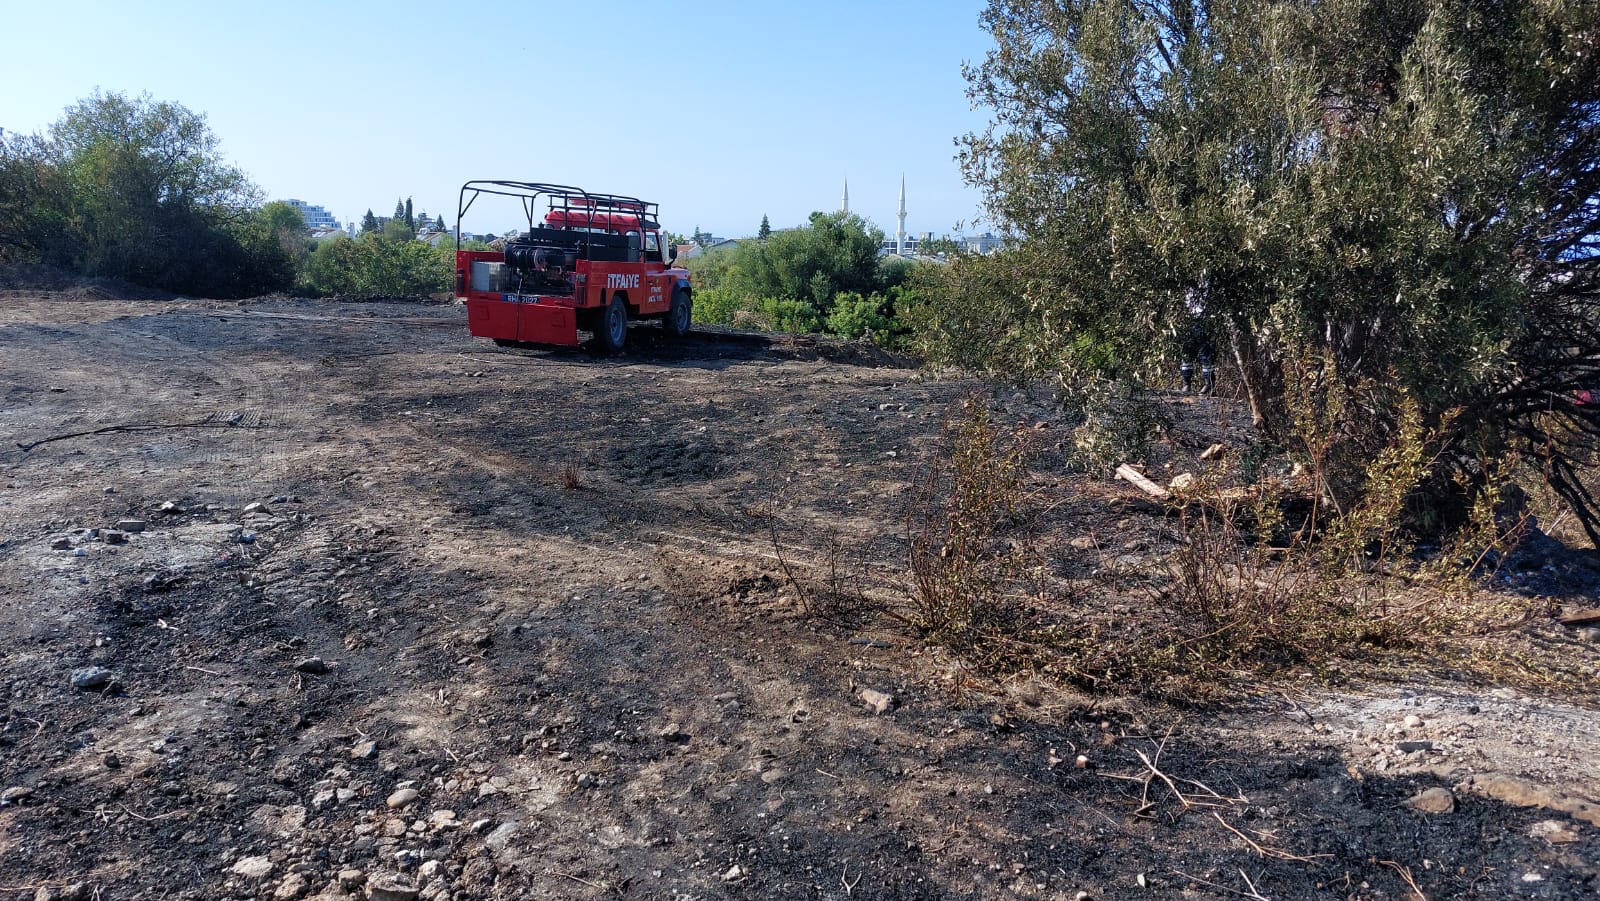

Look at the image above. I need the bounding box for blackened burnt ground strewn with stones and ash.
[0,290,1600,899]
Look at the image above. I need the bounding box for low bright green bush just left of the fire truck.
[301,235,454,298]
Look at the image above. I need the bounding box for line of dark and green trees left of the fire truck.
[0,93,454,298]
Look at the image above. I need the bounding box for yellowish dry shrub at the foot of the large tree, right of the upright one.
[1120,384,1523,693]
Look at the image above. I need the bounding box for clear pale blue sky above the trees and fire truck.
[0,0,989,235]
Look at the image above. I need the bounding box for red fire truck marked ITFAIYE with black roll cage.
[456,181,694,350]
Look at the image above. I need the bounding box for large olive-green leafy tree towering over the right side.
[953,0,1600,541]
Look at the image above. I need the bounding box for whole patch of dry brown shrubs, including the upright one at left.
[904,384,1525,701]
